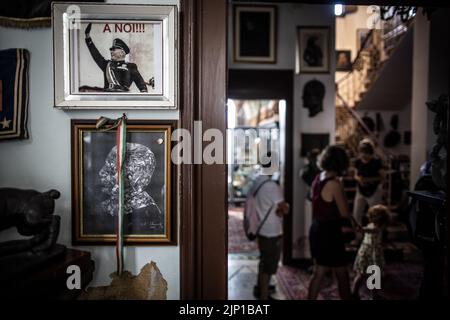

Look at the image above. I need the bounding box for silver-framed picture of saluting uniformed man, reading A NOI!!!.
[52,2,178,109]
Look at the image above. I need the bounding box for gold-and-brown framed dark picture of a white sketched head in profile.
[71,120,176,245]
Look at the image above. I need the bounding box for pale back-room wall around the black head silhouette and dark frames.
[228,3,335,258]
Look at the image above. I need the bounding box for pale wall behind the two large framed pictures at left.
[0,0,180,299]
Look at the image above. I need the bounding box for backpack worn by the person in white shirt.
[244,179,273,241]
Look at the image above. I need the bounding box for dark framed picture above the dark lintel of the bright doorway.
[233,5,277,63]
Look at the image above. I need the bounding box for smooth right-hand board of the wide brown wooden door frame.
[200,0,227,299]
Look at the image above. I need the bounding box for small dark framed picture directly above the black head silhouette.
[296,26,330,73]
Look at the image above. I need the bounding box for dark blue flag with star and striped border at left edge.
[0,49,30,140]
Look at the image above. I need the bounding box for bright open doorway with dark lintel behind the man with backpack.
[227,70,293,300]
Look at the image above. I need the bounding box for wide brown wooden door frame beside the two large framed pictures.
[179,0,228,299]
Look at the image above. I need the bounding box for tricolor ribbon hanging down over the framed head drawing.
[116,114,127,275]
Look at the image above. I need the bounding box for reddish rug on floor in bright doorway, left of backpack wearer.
[228,207,258,253]
